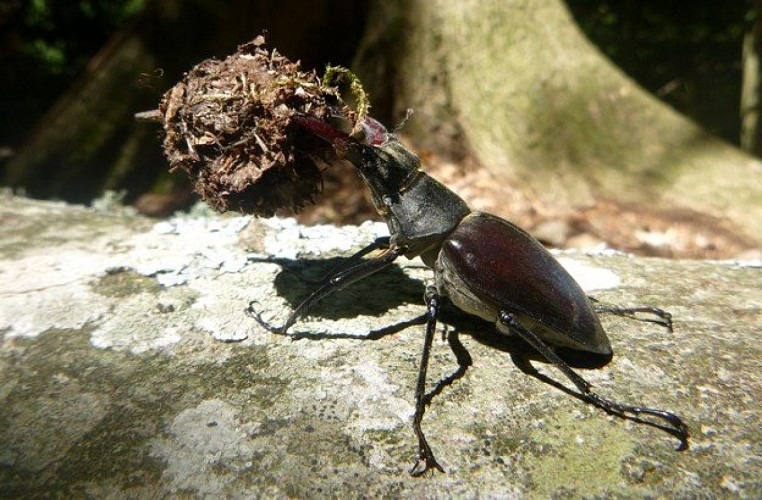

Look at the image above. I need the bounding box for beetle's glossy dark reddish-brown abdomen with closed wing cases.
[436,212,611,355]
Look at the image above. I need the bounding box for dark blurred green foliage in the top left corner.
[0,0,145,146]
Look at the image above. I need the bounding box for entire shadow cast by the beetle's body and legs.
[250,266,687,450]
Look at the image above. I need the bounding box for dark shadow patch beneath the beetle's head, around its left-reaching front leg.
[249,257,425,326]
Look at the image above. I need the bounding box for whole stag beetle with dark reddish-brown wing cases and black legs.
[248,115,688,476]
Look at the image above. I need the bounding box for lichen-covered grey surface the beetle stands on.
[0,194,762,498]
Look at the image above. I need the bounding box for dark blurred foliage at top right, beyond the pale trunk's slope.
[566,0,757,144]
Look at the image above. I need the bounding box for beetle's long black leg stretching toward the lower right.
[500,311,689,450]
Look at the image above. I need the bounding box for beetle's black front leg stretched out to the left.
[246,247,405,335]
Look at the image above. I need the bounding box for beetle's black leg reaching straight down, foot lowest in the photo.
[410,285,444,477]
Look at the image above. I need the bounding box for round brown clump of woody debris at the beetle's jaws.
[158,36,357,217]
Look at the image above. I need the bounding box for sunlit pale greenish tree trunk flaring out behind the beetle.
[357,0,762,246]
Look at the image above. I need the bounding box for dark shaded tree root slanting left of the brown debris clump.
[3,30,163,201]
